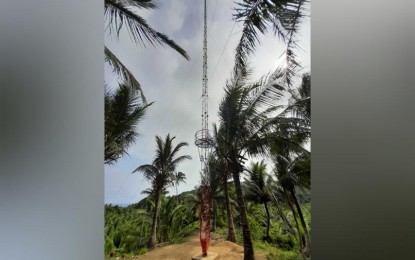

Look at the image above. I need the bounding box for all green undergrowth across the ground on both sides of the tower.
[105,190,311,260]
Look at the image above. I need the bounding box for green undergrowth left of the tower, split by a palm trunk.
[105,191,199,256]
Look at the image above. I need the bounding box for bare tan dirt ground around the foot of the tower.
[133,236,266,260]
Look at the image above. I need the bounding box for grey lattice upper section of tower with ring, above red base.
[195,0,214,185]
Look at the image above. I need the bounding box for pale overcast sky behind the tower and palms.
[105,0,310,204]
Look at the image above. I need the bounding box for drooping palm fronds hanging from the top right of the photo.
[233,0,308,85]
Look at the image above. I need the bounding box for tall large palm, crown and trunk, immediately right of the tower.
[219,71,288,259]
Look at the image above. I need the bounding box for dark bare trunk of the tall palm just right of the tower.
[232,170,255,260]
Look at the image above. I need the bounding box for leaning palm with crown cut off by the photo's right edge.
[270,74,311,254]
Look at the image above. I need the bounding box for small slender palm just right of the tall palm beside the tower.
[244,160,273,240]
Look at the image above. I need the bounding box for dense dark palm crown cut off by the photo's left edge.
[104,83,153,164]
